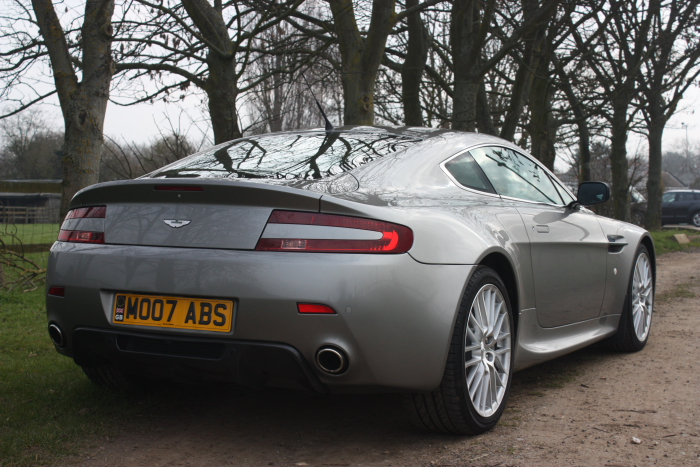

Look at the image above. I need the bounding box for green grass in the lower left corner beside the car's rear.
[0,287,154,467]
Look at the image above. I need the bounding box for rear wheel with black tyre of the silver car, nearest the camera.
[405,266,514,435]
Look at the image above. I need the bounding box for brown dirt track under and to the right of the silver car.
[73,252,700,467]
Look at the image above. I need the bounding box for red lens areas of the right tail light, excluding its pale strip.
[255,211,413,253]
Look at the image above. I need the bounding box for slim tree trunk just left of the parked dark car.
[644,105,666,230]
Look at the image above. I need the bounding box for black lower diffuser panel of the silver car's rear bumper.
[73,328,328,393]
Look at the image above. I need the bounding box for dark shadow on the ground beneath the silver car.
[97,346,619,465]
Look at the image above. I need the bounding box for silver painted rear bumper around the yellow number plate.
[47,242,473,392]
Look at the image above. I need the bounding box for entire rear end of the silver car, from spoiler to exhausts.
[47,132,470,392]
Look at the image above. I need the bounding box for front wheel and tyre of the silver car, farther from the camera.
[603,245,654,352]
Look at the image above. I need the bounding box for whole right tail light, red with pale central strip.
[255,211,413,253]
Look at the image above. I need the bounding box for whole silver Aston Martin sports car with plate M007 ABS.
[46,126,655,434]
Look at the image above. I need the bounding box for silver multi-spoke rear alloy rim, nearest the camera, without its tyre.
[464,284,511,417]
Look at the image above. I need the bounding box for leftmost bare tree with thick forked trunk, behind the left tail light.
[0,0,114,218]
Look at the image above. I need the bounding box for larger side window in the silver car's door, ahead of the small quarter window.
[470,147,563,204]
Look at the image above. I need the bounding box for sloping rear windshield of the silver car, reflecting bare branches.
[150,132,422,180]
